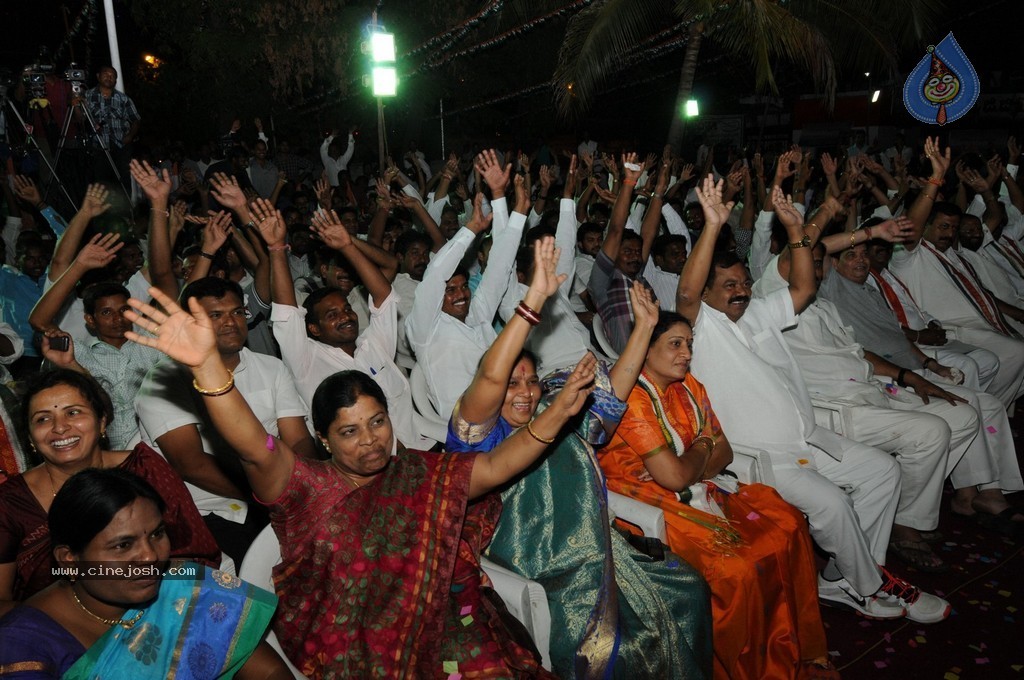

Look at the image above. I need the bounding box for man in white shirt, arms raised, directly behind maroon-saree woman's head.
[257,206,435,450]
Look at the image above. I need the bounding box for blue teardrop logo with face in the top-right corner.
[903,33,981,125]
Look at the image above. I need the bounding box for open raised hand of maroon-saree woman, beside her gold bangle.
[125,288,217,368]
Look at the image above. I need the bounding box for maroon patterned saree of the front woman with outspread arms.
[270,451,550,678]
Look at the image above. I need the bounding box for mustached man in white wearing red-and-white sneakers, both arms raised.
[676,176,949,623]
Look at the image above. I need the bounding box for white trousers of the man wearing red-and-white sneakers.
[772,439,900,597]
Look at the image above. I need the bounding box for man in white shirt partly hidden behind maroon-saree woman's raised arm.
[135,277,313,564]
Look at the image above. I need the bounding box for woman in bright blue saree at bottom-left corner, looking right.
[0,468,292,680]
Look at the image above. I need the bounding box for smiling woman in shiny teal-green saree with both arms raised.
[446,246,712,679]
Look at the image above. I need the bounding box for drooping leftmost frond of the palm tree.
[552,0,675,118]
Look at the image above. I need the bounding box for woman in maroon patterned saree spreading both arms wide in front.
[129,227,595,678]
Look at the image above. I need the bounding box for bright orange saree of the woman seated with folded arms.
[598,375,827,680]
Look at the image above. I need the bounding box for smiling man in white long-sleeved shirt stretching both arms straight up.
[406,150,526,418]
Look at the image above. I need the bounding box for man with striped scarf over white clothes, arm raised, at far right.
[889,138,1024,409]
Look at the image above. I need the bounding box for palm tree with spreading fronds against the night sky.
[553,0,944,146]
